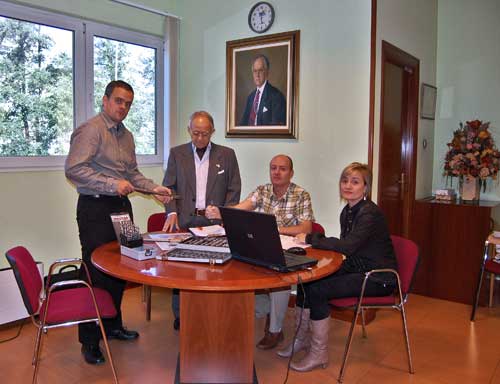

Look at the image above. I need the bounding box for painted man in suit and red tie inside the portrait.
[239,54,286,126]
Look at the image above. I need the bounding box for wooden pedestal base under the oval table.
[180,290,257,384]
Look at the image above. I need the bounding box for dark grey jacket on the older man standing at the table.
[163,142,241,228]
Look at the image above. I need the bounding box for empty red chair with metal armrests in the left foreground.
[5,247,118,383]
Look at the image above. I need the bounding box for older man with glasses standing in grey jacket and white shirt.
[163,111,241,329]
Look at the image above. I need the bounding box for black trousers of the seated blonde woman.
[297,268,395,320]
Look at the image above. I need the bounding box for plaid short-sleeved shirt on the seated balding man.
[248,183,314,227]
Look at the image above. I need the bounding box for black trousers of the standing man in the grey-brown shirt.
[76,195,133,344]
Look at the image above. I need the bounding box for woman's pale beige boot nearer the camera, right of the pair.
[290,317,330,372]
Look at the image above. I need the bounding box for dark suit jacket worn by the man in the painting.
[240,81,286,125]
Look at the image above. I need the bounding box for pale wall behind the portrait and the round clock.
[176,0,371,235]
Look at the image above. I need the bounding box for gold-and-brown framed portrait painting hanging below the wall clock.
[226,31,300,139]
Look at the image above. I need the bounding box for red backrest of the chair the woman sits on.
[391,235,419,295]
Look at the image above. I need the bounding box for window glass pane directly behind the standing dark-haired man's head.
[94,37,156,155]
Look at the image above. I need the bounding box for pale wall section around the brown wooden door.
[374,0,437,199]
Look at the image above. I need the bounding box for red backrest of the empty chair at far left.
[5,247,43,315]
